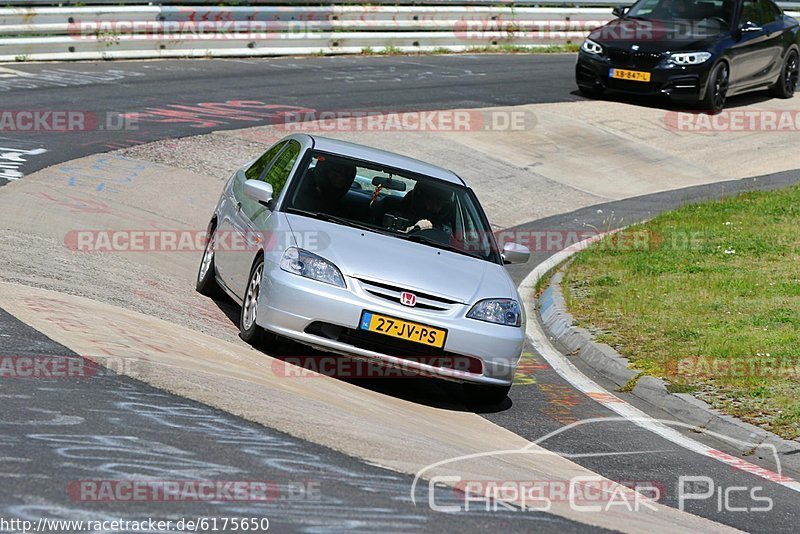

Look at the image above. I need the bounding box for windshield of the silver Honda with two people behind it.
[282,151,502,263]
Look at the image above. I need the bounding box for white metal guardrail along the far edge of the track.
[0,0,800,61]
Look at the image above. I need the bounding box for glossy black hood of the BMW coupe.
[589,19,724,53]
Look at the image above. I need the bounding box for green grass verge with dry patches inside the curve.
[563,186,800,439]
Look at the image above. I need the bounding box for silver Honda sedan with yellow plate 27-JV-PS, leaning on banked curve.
[197,134,530,403]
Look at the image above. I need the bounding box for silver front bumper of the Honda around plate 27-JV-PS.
[257,263,525,386]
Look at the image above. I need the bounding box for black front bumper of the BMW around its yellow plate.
[575,51,713,101]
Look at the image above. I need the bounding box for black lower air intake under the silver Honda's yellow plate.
[305,321,483,374]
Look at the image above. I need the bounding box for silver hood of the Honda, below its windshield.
[284,213,517,304]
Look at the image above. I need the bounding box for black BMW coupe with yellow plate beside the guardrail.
[575,0,800,112]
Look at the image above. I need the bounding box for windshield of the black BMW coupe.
[626,0,736,34]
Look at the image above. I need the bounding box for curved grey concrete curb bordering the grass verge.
[532,264,800,471]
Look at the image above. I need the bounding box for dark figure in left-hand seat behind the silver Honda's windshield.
[296,156,356,215]
